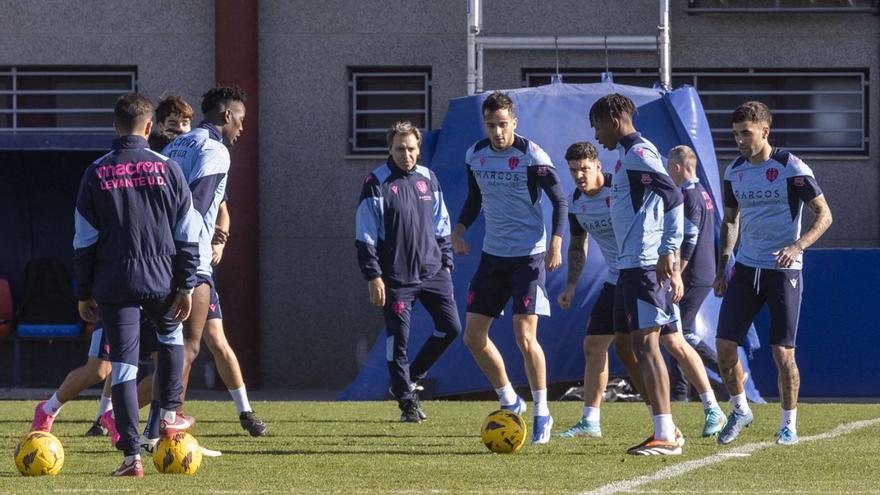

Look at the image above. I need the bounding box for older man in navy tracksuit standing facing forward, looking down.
[355,122,461,423]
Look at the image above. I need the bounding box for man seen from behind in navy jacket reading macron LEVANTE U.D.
[73,93,199,477]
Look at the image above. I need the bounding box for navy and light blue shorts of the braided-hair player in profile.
[614,267,678,335]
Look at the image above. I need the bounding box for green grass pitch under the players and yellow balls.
[0,400,880,494]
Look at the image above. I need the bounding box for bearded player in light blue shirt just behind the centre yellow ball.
[452,92,568,444]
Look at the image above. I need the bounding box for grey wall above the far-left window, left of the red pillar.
[0,0,214,121]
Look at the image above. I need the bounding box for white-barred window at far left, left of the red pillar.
[0,67,137,133]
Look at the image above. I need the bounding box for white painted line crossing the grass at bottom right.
[579,418,880,495]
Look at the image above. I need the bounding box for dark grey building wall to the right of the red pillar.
[260,0,880,388]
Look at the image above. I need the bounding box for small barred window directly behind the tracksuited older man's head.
[349,68,431,153]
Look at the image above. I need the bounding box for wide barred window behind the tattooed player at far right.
[523,69,869,155]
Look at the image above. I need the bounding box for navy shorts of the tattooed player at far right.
[716,263,804,347]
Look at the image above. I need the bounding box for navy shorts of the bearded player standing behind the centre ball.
[467,253,550,318]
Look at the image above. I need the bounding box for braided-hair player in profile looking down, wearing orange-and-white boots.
[590,93,683,455]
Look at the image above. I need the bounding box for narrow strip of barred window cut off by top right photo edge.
[684,0,880,14]
